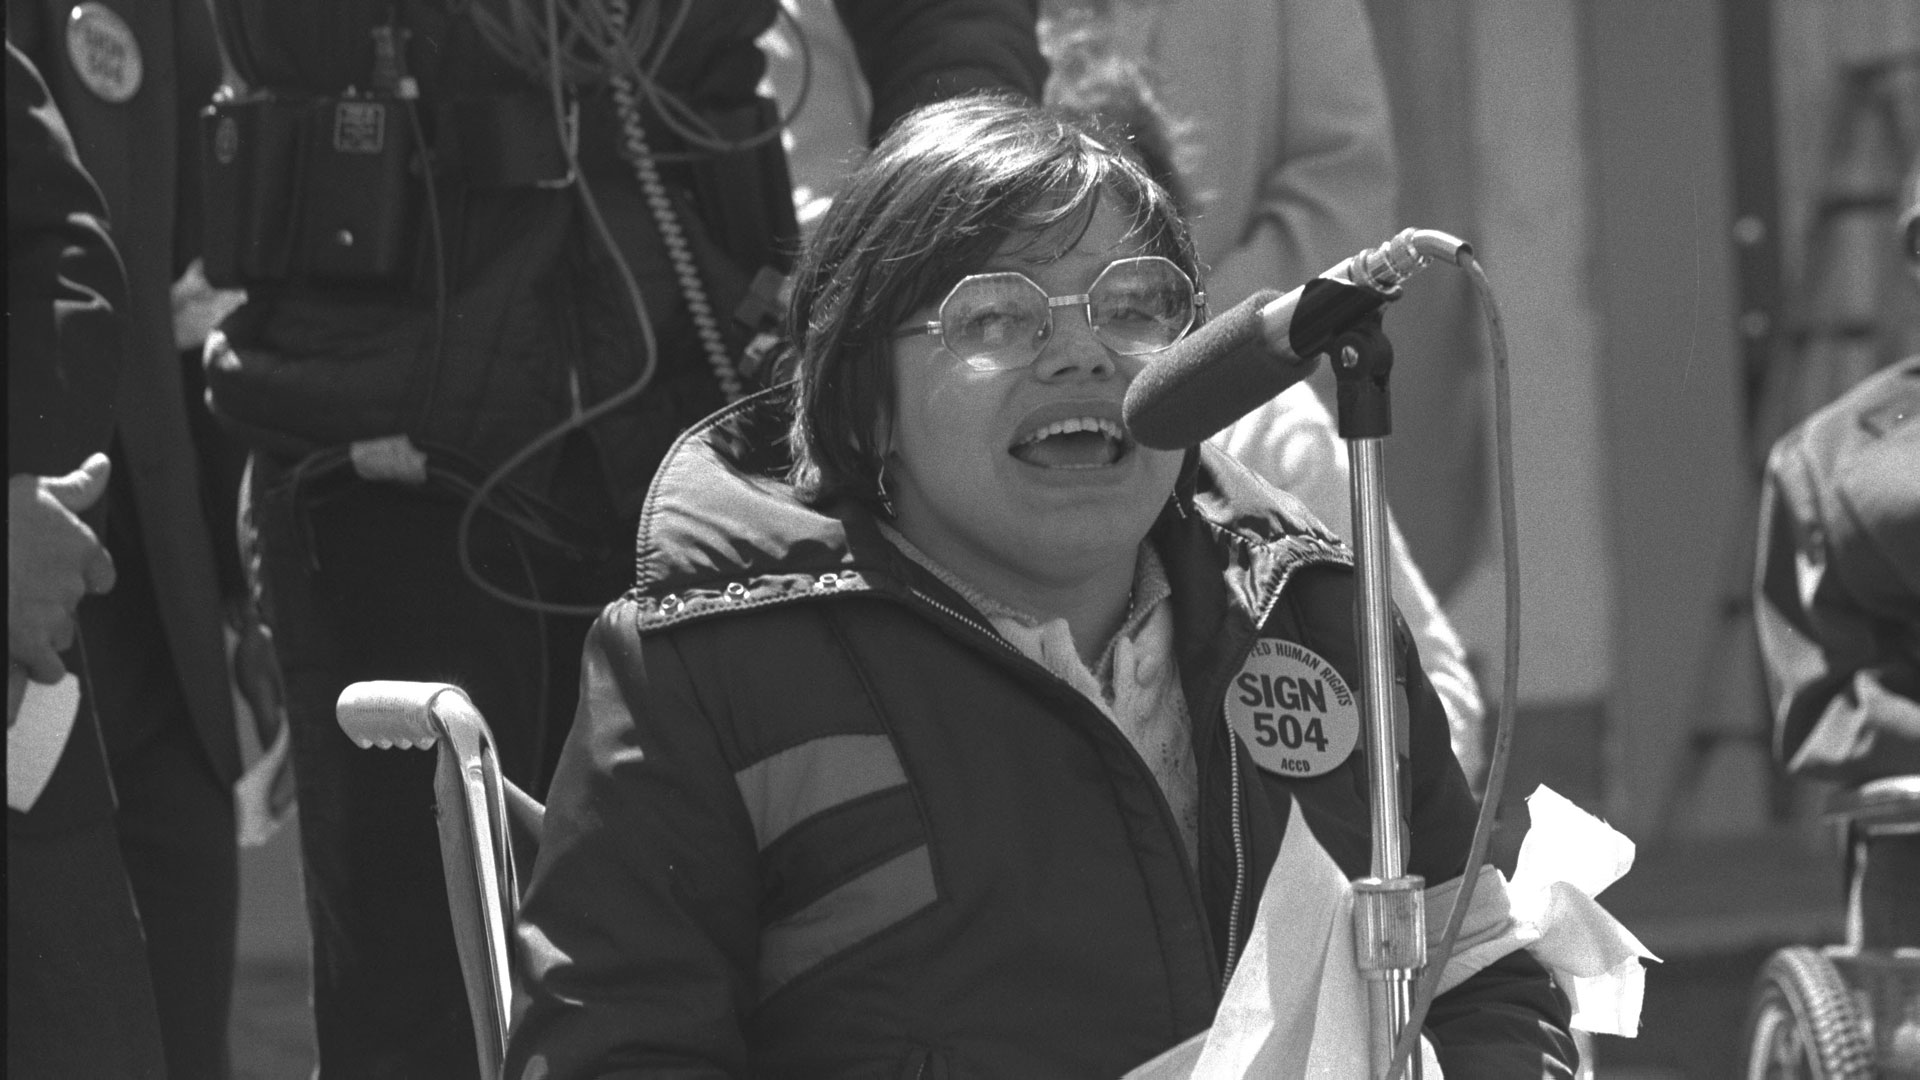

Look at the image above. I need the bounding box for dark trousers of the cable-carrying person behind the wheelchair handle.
[246,448,634,1080]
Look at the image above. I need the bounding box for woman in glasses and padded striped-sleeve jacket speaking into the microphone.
[507,98,1572,1080]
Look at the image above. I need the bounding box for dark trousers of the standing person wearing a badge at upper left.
[81,474,240,1080]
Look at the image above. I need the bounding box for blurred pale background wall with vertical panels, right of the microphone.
[1369,0,1920,844]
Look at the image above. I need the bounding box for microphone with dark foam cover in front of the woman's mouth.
[1121,229,1473,450]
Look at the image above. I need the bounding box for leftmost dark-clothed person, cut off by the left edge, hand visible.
[6,42,167,1080]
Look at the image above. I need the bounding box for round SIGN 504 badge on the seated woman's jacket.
[1227,638,1359,776]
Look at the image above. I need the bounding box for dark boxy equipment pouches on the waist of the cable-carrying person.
[200,92,417,288]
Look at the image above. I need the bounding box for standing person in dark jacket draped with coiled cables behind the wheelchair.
[207,0,1044,1080]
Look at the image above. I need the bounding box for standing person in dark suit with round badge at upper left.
[8,0,276,1078]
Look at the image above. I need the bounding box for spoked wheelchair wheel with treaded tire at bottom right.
[1743,945,1874,1080]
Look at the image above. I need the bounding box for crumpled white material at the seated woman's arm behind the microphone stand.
[1123,786,1655,1080]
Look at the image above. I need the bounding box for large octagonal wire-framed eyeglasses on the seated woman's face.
[895,256,1204,371]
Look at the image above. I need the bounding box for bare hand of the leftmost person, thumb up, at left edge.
[6,454,113,684]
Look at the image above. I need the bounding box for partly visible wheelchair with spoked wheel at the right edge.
[1741,776,1920,1080]
